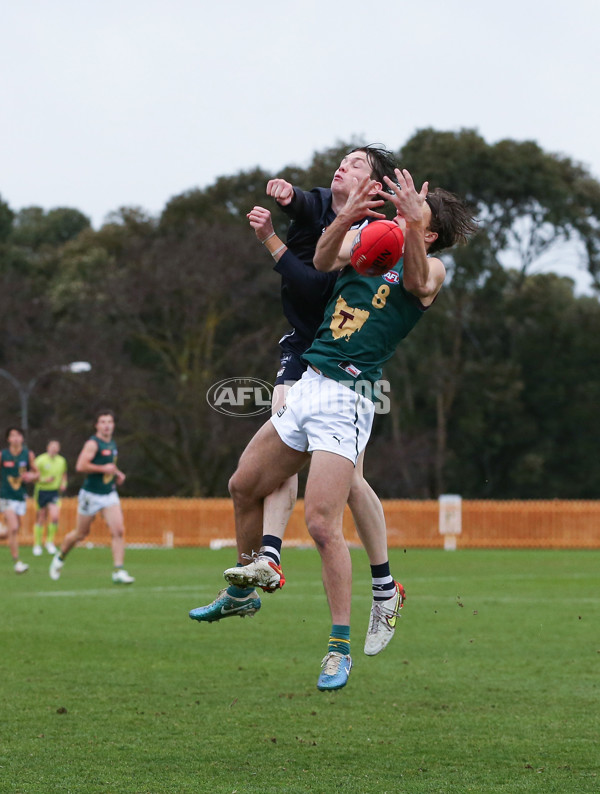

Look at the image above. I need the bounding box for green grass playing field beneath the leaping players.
[0,549,600,794]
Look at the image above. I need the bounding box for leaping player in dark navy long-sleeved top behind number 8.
[195,146,405,655]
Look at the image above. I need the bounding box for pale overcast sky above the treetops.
[0,0,600,290]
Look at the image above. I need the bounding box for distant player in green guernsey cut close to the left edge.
[0,427,39,573]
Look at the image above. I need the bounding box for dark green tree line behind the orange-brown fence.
[0,129,600,499]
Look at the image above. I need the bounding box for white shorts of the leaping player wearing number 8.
[271,367,375,465]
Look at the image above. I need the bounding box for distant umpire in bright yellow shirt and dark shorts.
[33,438,67,557]
